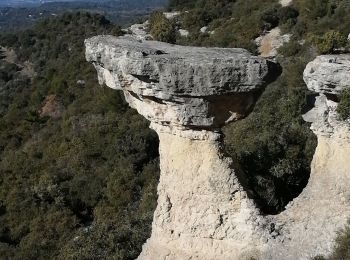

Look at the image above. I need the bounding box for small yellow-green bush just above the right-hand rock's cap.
[312,30,348,54]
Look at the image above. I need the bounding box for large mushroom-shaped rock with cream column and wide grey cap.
[86,36,276,260]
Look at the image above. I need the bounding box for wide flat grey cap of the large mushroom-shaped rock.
[85,36,278,129]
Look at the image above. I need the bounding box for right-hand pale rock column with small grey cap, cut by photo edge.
[270,55,350,259]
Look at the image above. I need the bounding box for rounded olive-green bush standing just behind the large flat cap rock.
[149,11,176,43]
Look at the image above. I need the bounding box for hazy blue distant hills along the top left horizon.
[0,0,168,31]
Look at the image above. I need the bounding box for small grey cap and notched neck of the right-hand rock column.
[303,54,350,137]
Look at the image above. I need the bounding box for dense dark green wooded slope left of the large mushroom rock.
[0,13,159,259]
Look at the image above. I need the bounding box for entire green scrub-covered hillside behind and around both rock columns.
[0,0,350,259]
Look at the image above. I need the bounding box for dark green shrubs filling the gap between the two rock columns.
[225,59,316,214]
